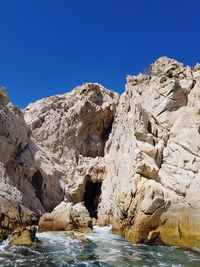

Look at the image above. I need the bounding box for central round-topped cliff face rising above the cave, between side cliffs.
[24,84,119,207]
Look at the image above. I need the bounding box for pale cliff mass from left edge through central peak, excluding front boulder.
[0,84,119,234]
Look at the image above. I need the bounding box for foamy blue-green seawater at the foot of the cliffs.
[0,227,200,267]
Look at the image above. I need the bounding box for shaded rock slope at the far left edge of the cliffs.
[0,89,40,230]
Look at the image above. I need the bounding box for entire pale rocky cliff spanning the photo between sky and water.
[0,57,200,247]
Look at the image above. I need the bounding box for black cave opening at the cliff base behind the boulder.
[83,181,102,219]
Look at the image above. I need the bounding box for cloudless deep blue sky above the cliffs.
[0,0,200,108]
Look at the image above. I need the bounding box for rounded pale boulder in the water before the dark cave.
[38,201,92,232]
